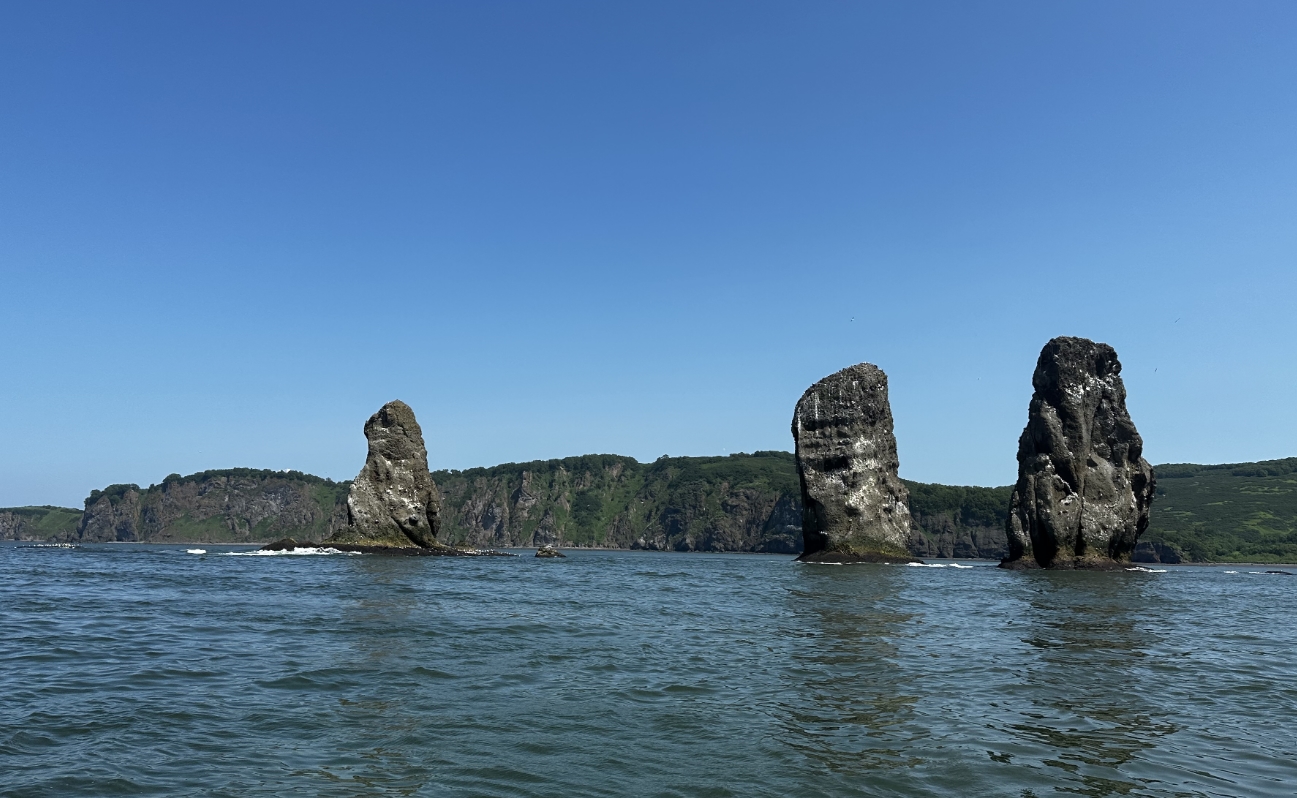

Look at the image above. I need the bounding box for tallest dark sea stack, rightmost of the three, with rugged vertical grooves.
[1003,337,1156,568]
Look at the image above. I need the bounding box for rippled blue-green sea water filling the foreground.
[0,544,1297,798]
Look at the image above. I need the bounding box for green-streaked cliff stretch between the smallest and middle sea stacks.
[434,452,800,553]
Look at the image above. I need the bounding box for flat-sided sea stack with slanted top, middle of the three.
[792,363,912,562]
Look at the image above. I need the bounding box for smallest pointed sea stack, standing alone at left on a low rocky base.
[329,401,446,549]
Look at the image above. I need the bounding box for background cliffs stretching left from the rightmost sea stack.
[50,452,1009,559]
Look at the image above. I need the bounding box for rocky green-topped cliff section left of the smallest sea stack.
[71,468,346,544]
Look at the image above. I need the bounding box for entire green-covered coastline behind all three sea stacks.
[10,452,1297,562]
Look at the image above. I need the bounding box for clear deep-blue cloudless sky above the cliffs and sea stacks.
[0,0,1297,506]
